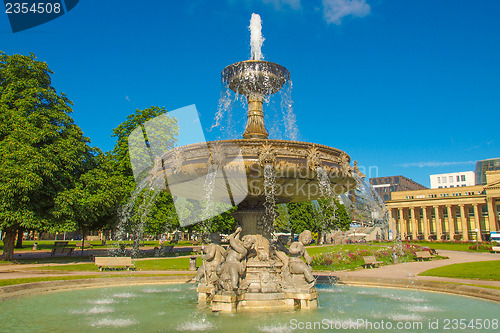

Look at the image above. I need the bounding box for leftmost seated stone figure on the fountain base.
[194,232,226,286]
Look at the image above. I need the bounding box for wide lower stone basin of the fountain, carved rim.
[156,139,356,205]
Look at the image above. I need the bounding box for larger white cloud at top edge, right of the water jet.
[323,0,371,25]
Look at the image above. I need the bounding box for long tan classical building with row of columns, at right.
[386,171,500,241]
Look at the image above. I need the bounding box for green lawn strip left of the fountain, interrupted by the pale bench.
[21,257,201,272]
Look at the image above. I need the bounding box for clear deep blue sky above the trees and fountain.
[0,0,500,186]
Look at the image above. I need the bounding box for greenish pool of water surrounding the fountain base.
[0,284,500,333]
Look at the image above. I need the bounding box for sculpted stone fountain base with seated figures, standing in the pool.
[197,227,318,312]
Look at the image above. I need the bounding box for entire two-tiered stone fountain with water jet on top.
[146,14,356,311]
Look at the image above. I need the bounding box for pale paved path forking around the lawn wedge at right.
[326,250,500,287]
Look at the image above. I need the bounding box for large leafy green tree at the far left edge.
[0,52,94,260]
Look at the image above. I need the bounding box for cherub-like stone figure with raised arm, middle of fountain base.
[217,227,255,292]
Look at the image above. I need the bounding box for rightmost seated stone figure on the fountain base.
[288,230,316,287]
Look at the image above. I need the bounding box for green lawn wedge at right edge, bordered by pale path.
[419,260,500,281]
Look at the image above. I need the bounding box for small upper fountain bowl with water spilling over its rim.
[222,60,290,96]
